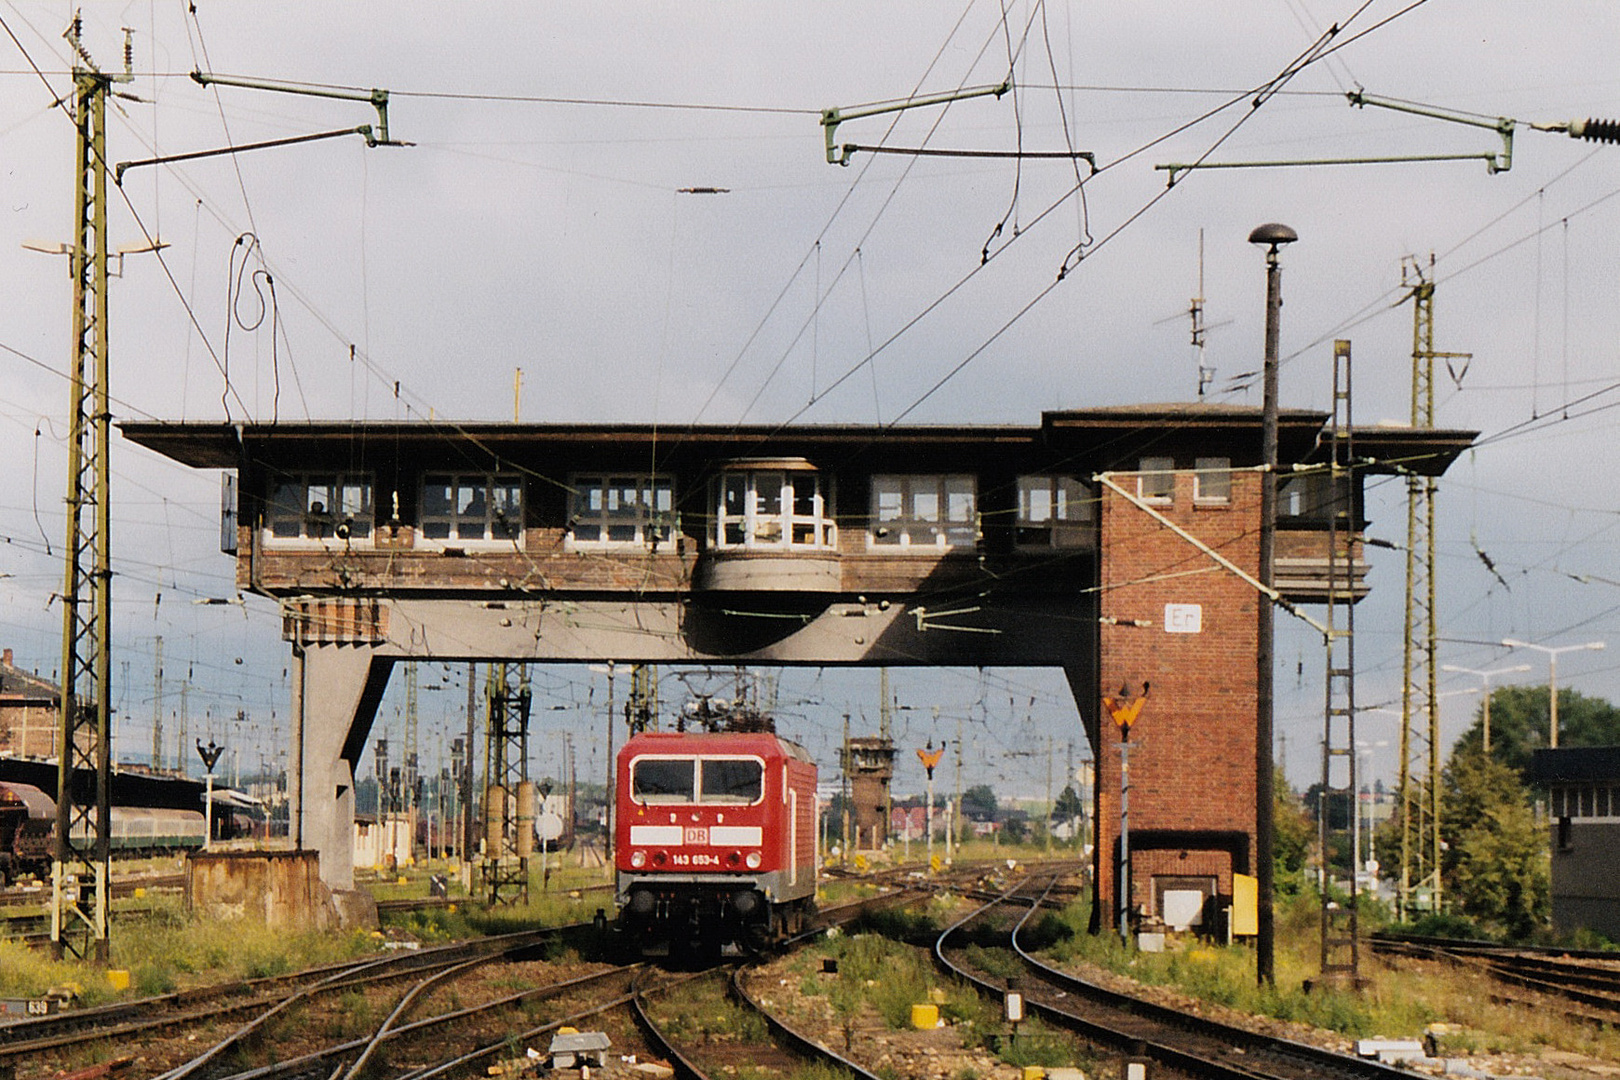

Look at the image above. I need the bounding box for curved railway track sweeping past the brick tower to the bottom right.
[935,889,1411,1080]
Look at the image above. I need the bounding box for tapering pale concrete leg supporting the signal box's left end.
[287,644,394,889]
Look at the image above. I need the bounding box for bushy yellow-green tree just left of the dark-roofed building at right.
[1440,751,1552,938]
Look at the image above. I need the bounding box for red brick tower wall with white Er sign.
[1082,473,1260,923]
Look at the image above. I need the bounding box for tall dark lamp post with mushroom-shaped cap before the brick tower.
[1249,222,1299,986]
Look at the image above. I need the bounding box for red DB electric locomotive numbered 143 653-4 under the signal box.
[614,730,816,955]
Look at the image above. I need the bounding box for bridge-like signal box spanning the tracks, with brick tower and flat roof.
[122,403,1473,915]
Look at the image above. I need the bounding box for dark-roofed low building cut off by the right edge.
[1529,746,1620,941]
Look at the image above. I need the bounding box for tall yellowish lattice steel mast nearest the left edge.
[50,16,134,963]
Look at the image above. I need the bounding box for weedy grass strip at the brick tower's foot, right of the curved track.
[1024,897,1620,1061]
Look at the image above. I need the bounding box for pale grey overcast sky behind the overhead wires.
[0,0,1620,803]
